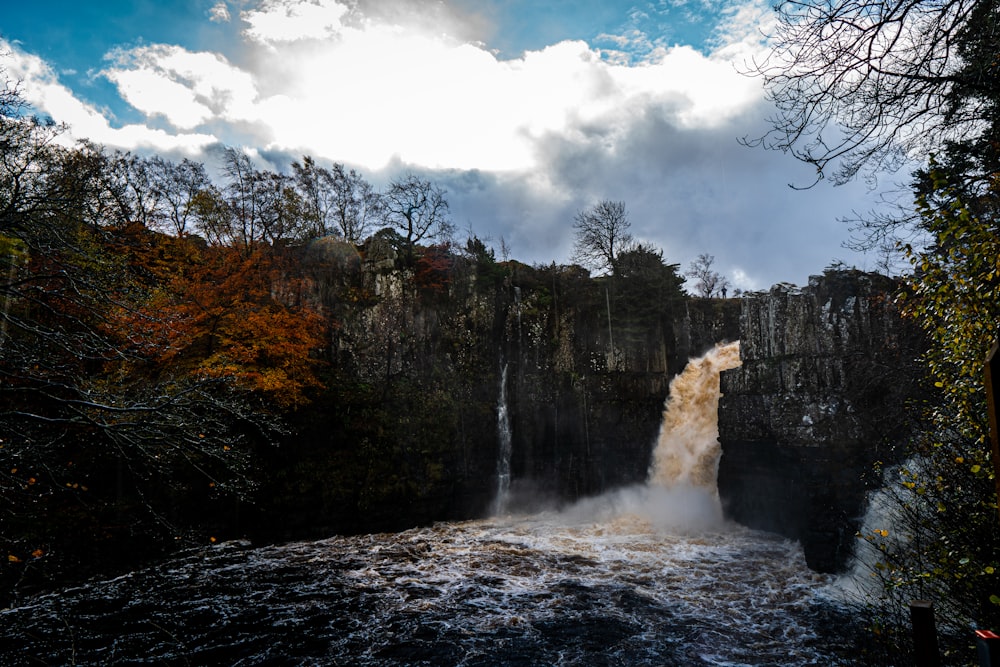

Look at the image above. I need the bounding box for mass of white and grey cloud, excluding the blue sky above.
[3,0,876,289]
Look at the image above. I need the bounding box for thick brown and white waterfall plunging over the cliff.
[648,341,741,516]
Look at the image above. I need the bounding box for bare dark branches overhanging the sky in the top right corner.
[749,0,1000,189]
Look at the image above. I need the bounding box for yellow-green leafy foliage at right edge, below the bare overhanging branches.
[861,161,1000,663]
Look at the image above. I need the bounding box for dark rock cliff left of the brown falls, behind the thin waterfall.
[256,250,739,539]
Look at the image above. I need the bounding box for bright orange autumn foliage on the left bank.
[109,236,325,409]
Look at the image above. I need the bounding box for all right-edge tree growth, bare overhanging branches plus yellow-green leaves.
[756,0,1000,662]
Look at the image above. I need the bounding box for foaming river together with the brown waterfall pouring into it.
[0,347,850,666]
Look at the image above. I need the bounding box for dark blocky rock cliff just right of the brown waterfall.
[719,271,922,572]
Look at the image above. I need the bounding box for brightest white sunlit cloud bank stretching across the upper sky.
[84,0,759,171]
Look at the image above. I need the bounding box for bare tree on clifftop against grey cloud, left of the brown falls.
[573,199,633,275]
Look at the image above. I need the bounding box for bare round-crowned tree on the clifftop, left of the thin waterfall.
[383,174,454,263]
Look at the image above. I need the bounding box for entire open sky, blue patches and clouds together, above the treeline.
[0,0,892,290]
